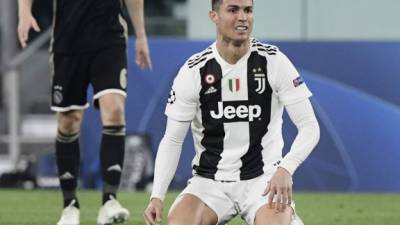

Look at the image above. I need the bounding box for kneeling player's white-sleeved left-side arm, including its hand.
[143,118,190,225]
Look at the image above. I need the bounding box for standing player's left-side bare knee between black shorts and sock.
[57,111,83,134]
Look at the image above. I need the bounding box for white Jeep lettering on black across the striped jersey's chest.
[210,101,261,122]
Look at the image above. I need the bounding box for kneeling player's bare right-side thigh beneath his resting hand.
[254,203,293,225]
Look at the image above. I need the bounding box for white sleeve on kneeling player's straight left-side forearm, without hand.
[151,119,190,200]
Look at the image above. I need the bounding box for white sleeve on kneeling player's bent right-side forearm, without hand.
[280,99,320,175]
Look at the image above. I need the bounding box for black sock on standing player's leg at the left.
[56,131,80,208]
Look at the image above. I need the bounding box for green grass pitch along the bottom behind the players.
[0,189,400,225]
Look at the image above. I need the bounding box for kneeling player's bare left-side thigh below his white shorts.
[167,194,218,225]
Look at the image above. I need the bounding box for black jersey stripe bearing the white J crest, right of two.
[240,51,272,180]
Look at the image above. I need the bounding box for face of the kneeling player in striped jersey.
[210,0,253,43]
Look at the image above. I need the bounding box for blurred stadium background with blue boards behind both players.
[0,0,400,192]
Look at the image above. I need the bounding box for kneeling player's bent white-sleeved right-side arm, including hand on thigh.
[264,99,320,211]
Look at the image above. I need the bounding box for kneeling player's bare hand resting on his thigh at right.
[263,167,293,212]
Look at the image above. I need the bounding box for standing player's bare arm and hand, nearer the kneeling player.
[125,0,152,69]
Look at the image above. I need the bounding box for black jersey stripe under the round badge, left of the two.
[193,59,225,179]
